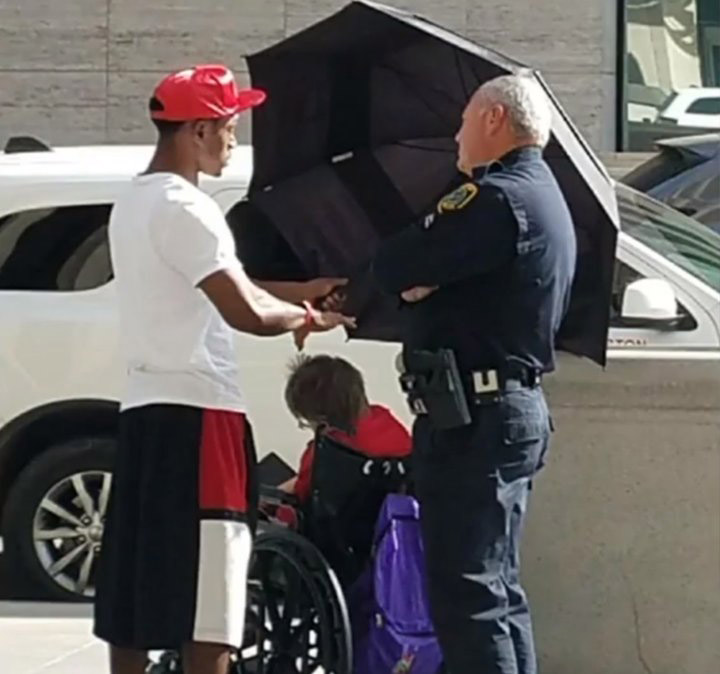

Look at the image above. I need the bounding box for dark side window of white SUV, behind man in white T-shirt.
[0,204,112,291]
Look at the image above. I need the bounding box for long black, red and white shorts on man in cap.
[95,405,256,650]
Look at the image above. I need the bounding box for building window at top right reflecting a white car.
[619,0,720,151]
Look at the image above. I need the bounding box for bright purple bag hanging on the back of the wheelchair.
[348,494,442,674]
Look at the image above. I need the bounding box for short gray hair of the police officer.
[477,74,552,147]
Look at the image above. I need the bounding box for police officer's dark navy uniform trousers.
[413,387,550,674]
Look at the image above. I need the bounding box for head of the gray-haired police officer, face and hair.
[456,75,552,172]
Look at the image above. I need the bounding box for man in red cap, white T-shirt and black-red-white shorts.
[95,65,353,674]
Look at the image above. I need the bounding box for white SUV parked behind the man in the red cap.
[0,139,402,599]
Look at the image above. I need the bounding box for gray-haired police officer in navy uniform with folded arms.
[373,75,576,674]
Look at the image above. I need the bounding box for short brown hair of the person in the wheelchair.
[285,355,368,433]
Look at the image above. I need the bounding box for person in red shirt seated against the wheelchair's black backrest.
[280,355,412,583]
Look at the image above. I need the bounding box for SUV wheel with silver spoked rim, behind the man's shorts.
[2,437,115,602]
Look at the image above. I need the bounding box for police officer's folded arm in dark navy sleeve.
[372,187,517,302]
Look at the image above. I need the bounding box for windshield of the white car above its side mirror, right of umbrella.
[616,184,720,292]
